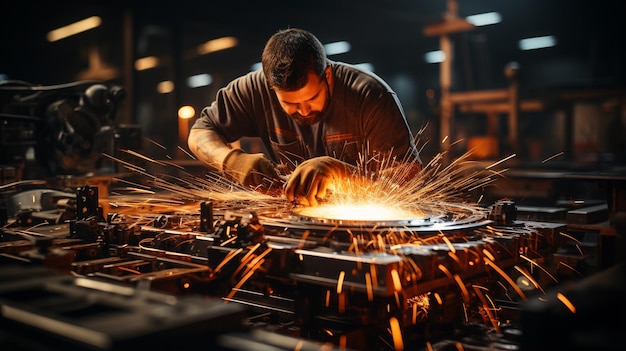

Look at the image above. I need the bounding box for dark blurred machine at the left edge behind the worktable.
[0,81,125,184]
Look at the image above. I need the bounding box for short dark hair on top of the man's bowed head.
[261,28,328,91]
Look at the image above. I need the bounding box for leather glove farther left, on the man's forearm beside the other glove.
[222,149,284,189]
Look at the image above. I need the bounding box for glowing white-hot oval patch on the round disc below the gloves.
[298,204,418,221]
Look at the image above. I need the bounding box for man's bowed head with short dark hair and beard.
[261,28,332,125]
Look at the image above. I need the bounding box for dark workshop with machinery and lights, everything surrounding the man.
[0,0,626,351]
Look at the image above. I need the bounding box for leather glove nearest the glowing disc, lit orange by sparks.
[285,156,355,206]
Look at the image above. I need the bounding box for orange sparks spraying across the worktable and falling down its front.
[95,136,584,350]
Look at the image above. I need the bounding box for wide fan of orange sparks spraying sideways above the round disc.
[105,130,514,226]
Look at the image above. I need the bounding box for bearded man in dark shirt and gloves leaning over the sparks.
[188,28,421,205]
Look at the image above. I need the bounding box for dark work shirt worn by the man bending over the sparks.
[192,61,421,173]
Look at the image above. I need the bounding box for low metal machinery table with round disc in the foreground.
[0,180,576,350]
